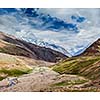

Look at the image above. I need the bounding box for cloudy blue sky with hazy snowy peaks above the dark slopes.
[0,8,100,56]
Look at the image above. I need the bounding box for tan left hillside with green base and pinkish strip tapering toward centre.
[0,53,53,80]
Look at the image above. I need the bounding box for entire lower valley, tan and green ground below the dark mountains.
[0,53,100,92]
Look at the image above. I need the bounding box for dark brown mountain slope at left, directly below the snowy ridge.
[0,32,67,62]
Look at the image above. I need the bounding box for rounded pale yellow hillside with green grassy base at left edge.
[0,53,32,80]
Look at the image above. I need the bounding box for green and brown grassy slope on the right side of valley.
[51,56,100,80]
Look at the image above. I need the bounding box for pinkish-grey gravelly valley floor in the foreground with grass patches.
[0,67,100,92]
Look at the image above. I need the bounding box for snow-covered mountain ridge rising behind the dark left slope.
[16,32,71,57]
